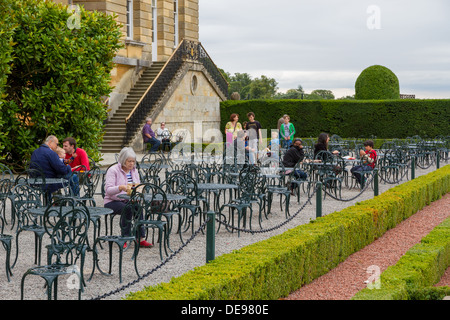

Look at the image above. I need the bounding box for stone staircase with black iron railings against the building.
[101,40,228,153]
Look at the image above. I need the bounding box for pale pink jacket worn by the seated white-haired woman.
[103,163,141,204]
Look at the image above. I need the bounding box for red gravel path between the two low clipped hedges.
[284,193,450,300]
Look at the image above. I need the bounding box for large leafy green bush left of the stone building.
[1,0,121,169]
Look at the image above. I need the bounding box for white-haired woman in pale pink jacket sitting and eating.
[103,147,153,248]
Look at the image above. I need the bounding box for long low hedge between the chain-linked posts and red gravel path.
[127,165,450,300]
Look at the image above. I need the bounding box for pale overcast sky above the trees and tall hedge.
[200,0,450,98]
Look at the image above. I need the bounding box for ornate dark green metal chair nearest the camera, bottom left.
[20,206,90,300]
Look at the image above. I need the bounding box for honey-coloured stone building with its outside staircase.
[54,0,228,153]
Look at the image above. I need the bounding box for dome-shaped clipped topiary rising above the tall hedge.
[355,65,400,100]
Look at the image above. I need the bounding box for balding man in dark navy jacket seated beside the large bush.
[30,135,79,200]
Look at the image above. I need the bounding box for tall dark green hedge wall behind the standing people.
[220,99,450,139]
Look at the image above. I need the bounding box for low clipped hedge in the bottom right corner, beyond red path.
[352,218,450,300]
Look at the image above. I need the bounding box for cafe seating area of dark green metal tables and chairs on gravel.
[0,136,450,299]
